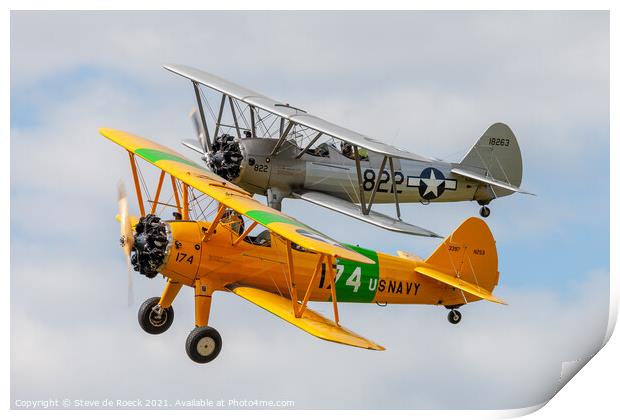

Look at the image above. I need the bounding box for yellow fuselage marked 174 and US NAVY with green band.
[160,221,478,306]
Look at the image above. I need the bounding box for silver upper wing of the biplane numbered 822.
[164,65,432,162]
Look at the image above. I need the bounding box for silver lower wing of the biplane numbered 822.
[293,191,441,238]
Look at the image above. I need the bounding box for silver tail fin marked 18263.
[459,123,523,188]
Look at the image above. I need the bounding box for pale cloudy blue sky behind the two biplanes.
[10,12,610,409]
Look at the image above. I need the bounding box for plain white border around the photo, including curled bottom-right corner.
[0,0,620,419]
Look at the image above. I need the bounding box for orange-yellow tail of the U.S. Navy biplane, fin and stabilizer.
[424,217,504,303]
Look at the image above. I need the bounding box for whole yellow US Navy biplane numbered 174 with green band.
[100,128,504,363]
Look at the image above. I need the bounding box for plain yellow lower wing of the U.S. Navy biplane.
[231,286,385,350]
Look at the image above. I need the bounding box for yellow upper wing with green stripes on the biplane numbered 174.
[99,128,374,264]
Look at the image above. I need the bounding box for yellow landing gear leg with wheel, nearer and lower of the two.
[185,279,222,363]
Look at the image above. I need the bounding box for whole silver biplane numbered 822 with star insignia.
[164,65,529,237]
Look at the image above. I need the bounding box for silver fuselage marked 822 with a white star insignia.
[234,138,511,203]
